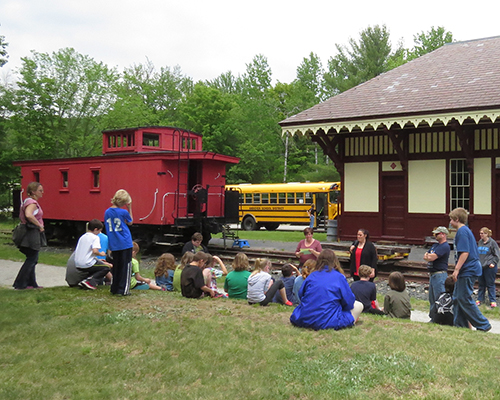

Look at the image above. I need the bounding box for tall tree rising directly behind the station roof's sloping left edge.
[324,25,399,95]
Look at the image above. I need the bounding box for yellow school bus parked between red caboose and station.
[226,182,340,231]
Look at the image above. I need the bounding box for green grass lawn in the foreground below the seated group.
[0,288,500,400]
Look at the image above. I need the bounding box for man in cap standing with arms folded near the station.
[424,226,450,316]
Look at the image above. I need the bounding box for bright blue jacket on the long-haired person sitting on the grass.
[290,266,356,330]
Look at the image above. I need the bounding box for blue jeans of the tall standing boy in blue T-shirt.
[453,276,491,331]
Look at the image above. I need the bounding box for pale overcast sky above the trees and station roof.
[0,0,500,83]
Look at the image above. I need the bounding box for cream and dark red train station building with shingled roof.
[280,37,500,244]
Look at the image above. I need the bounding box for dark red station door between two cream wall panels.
[382,175,406,237]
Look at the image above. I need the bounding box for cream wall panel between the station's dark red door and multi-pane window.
[408,160,447,214]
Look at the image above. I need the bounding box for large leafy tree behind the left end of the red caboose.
[7,48,118,159]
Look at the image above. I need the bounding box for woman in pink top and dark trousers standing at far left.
[13,182,46,290]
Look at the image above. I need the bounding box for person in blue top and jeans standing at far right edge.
[476,227,500,308]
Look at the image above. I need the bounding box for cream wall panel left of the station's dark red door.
[342,162,379,212]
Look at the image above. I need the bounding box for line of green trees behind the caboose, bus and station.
[0,25,453,208]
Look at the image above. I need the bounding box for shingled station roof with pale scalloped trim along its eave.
[280,36,500,134]
